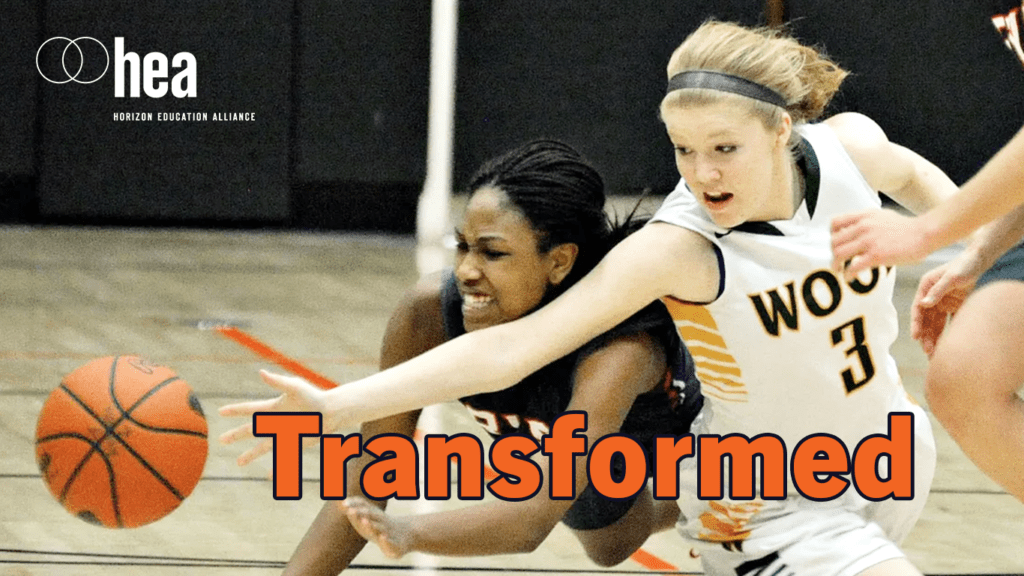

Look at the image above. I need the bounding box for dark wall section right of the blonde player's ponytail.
[786,0,1024,182]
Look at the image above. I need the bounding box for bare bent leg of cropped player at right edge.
[926,281,1024,502]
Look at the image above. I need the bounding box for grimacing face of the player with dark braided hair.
[456,188,554,331]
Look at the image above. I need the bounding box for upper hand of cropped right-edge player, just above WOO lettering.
[831,209,931,280]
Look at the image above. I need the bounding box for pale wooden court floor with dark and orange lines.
[0,227,1024,576]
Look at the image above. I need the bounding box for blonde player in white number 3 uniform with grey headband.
[223,22,955,576]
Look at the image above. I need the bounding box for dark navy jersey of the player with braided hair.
[441,271,703,454]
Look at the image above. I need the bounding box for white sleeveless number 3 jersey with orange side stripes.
[652,124,934,557]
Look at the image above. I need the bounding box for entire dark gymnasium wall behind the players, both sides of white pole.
[0,0,1024,233]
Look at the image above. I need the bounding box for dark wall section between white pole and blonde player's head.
[455,0,764,194]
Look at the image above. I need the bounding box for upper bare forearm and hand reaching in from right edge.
[833,120,1024,269]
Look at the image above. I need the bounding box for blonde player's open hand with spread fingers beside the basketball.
[219,370,340,466]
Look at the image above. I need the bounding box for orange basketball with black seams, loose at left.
[36,356,208,528]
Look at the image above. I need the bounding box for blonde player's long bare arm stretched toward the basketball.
[221,223,719,460]
